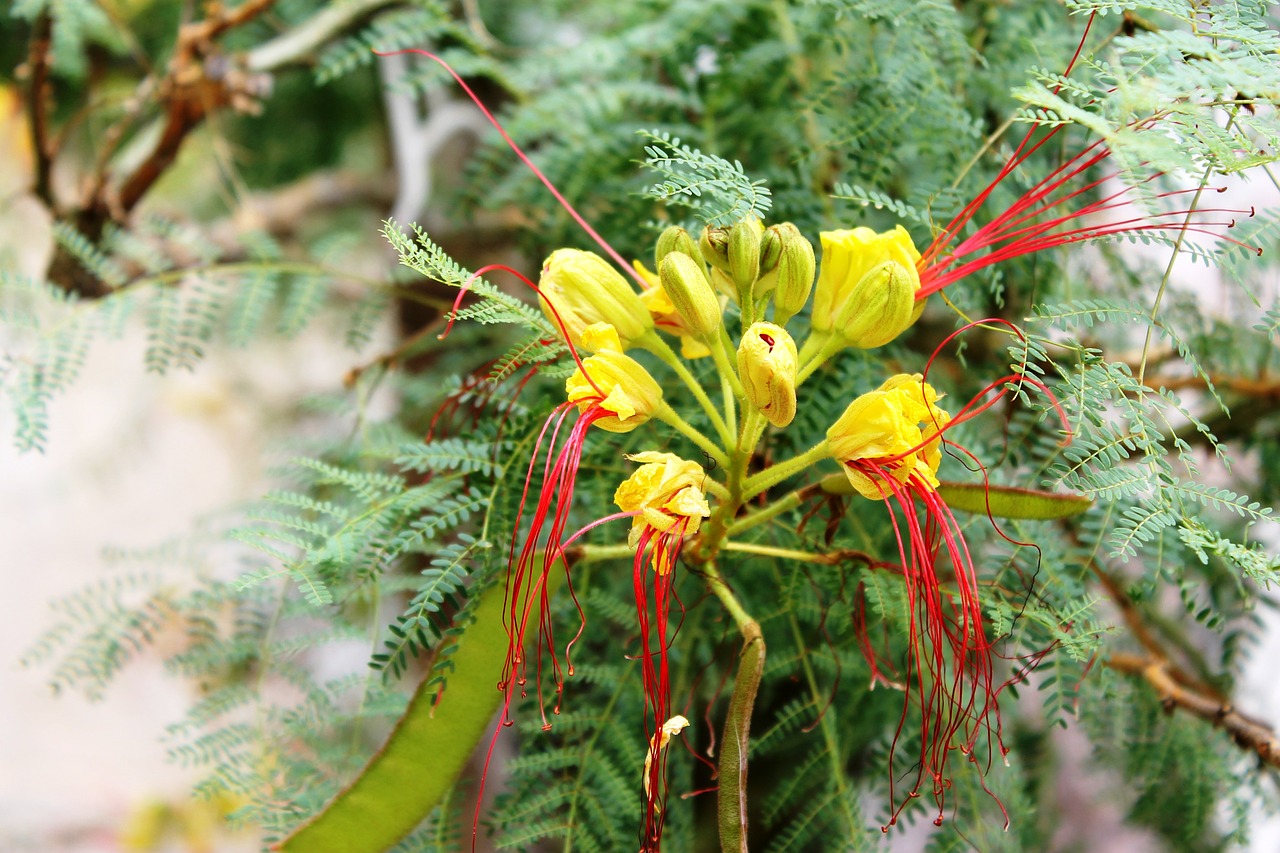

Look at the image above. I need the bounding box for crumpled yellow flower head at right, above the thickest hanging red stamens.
[827,374,951,501]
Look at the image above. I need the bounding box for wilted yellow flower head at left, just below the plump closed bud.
[564,323,662,433]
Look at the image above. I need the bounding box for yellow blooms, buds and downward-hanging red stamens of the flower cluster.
[503,213,1024,849]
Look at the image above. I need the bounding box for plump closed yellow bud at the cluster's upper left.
[538,248,653,347]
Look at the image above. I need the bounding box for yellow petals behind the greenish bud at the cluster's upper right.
[813,225,920,346]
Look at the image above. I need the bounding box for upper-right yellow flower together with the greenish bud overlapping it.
[813,225,920,348]
